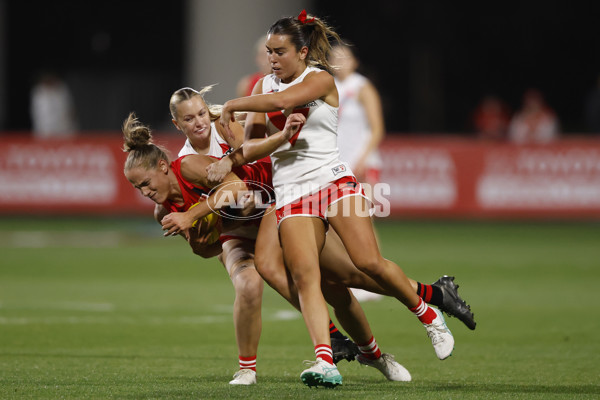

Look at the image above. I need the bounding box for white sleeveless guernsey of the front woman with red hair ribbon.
[263,67,352,208]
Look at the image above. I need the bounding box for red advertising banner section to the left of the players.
[0,132,183,215]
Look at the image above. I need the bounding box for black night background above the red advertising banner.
[0,0,600,134]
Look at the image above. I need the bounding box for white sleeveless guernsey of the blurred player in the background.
[335,72,381,169]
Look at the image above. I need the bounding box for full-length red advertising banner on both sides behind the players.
[0,132,600,218]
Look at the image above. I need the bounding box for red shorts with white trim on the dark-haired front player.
[275,176,370,227]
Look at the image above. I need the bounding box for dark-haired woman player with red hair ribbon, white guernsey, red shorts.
[220,11,454,386]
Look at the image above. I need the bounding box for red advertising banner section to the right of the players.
[381,138,600,218]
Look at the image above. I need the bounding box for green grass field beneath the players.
[0,217,600,400]
